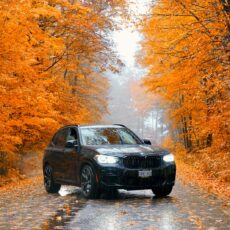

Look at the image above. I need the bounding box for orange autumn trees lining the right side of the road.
[141,0,230,178]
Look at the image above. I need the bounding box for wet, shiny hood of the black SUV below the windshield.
[82,145,168,157]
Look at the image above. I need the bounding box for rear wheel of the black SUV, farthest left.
[44,164,61,193]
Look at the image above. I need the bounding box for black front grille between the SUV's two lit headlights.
[123,156,162,169]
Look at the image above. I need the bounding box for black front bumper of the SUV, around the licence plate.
[97,164,176,190]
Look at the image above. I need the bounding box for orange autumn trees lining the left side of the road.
[0,0,124,175]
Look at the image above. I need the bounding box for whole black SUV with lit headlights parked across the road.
[43,125,176,198]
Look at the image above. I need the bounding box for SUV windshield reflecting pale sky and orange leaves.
[80,127,142,145]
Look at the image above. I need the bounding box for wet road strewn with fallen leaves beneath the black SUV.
[0,182,230,230]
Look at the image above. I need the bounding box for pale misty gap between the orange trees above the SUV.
[103,0,168,145]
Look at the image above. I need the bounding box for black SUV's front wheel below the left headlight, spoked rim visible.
[81,165,100,199]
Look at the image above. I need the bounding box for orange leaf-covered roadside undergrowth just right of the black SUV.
[176,153,230,199]
